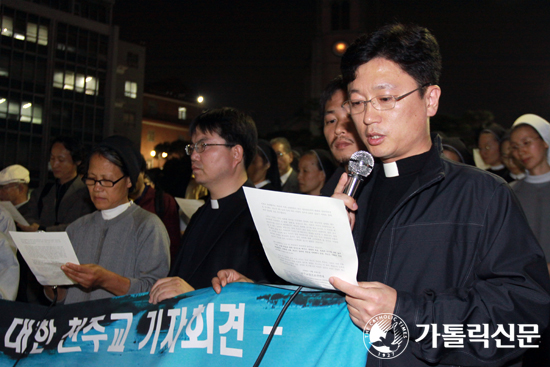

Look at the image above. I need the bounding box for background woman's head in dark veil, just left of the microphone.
[298,149,336,195]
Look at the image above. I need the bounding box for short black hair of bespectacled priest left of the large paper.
[189,107,258,169]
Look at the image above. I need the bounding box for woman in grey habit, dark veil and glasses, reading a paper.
[50,136,170,304]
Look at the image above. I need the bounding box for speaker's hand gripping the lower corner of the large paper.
[329,277,397,329]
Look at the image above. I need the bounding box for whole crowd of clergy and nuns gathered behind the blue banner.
[0,20,550,366]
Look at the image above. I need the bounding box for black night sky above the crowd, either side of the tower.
[114,0,550,138]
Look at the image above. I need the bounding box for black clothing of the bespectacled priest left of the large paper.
[170,181,281,289]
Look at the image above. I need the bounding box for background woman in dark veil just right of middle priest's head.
[246,139,281,191]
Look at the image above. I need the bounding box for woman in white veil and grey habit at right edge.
[510,114,550,269]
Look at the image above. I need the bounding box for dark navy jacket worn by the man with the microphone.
[353,138,550,367]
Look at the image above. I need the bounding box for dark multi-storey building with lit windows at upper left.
[0,0,145,184]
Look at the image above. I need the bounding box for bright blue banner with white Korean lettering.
[0,283,367,367]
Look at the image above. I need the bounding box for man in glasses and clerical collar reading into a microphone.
[331,24,550,366]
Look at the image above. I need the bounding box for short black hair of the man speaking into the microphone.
[340,23,441,97]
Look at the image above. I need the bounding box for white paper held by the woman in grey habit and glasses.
[10,231,80,285]
